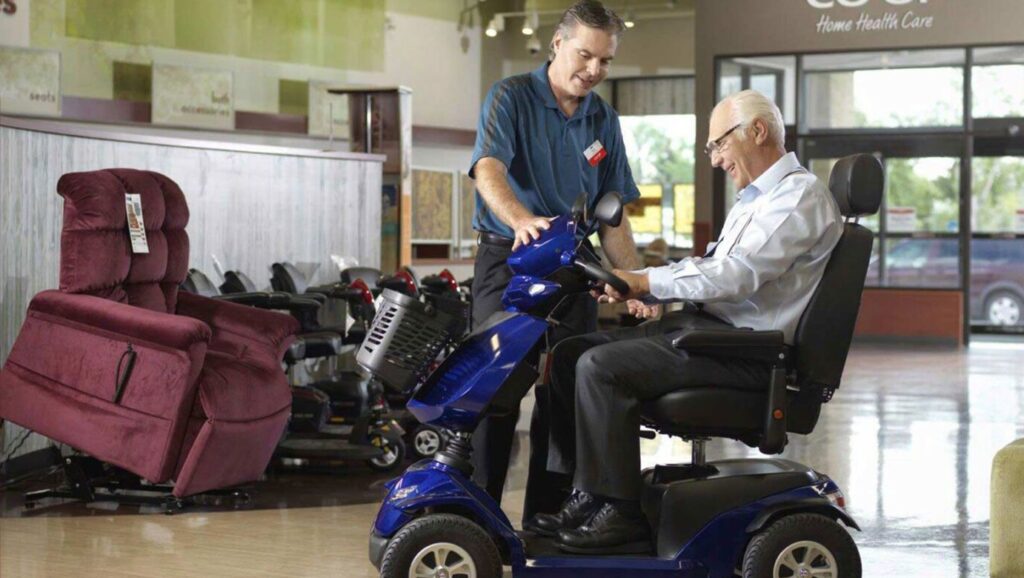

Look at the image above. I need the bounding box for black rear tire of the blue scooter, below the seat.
[743,513,860,578]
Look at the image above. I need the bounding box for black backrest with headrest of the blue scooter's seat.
[788,155,885,432]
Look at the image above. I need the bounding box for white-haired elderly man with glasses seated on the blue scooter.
[526,90,843,553]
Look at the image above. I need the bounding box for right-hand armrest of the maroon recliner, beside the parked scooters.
[177,292,299,364]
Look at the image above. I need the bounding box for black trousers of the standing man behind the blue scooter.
[472,243,597,520]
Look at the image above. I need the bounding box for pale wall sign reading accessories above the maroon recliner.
[153,65,234,130]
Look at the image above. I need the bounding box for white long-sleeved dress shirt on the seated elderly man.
[646,153,843,344]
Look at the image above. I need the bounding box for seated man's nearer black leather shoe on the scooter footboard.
[558,503,651,555]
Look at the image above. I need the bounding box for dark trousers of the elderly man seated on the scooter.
[548,307,770,500]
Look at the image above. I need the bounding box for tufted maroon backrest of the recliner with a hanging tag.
[57,169,188,313]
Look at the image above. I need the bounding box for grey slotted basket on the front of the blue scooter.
[355,289,469,391]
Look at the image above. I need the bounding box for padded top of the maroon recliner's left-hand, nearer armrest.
[29,290,212,350]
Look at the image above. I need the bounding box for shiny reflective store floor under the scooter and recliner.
[0,340,1024,578]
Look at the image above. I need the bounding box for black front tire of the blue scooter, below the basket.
[381,513,502,578]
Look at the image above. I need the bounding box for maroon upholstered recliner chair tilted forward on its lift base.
[0,169,298,498]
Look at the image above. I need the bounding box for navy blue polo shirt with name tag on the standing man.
[469,63,640,237]
